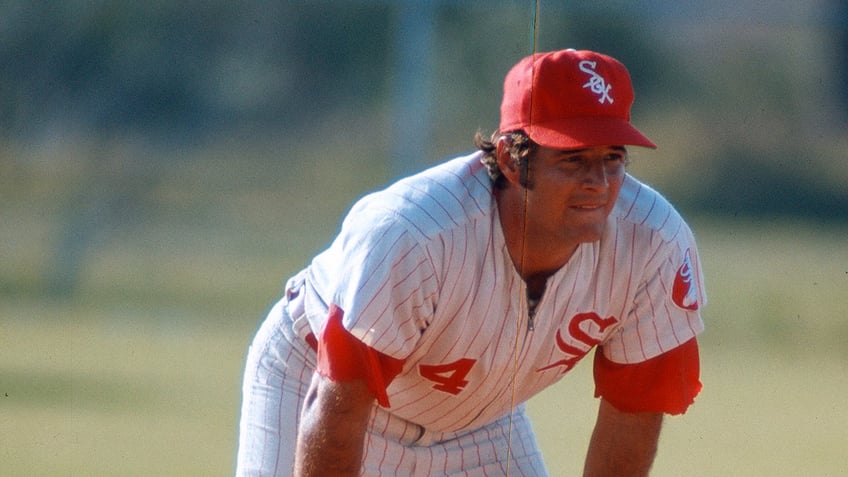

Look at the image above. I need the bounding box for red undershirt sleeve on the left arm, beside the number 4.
[317,305,404,407]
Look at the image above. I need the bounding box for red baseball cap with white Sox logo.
[499,50,657,149]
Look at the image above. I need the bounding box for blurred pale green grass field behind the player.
[0,211,848,477]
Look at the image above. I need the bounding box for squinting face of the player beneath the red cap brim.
[526,146,627,246]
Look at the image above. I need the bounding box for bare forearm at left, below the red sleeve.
[294,373,374,477]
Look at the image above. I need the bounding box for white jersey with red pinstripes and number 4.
[295,153,705,432]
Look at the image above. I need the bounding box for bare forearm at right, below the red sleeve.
[583,399,663,477]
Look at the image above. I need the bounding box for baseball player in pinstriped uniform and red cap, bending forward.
[237,50,705,477]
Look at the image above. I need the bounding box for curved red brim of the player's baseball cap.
[525,117,657,149]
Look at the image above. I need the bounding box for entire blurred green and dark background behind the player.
[0,0,848,476]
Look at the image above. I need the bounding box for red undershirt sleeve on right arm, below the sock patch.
[594,338,702,414]
